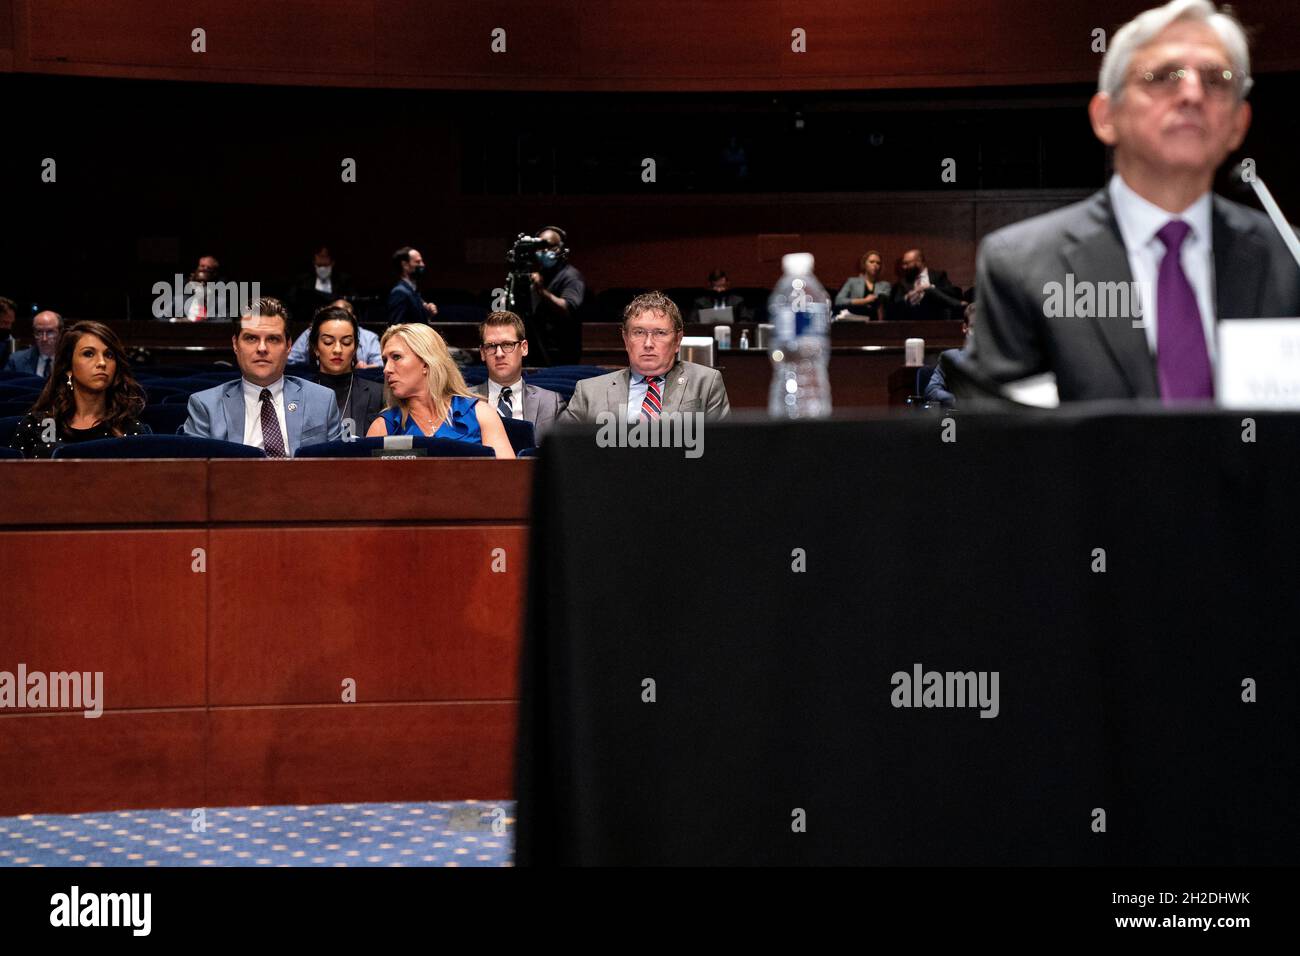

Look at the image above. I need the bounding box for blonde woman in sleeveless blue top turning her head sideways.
[367,324,515,458]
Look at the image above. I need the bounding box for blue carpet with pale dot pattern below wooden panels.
[0,800,515,866]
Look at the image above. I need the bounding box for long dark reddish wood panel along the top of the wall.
[12,0,1300,90]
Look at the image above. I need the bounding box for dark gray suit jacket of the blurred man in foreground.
[953,189,1300,402]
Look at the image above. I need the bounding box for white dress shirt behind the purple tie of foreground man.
[1109,173,1216,368]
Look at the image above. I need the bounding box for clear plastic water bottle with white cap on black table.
[767,252,831,419]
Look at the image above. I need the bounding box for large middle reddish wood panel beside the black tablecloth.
[208,528,527,706]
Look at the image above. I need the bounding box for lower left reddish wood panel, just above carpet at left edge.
[0,710,207,816]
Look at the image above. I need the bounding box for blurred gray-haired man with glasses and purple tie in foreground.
[953,0,1300,405]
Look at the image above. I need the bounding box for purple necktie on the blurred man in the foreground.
[1156,219,1214,403]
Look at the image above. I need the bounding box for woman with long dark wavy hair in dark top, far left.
[10,321,150,458]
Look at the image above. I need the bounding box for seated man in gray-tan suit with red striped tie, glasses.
[560,291,731,424]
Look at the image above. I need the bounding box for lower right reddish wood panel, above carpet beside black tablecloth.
[207,702,516,806]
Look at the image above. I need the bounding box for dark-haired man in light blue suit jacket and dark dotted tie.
[182,298,343,458]
